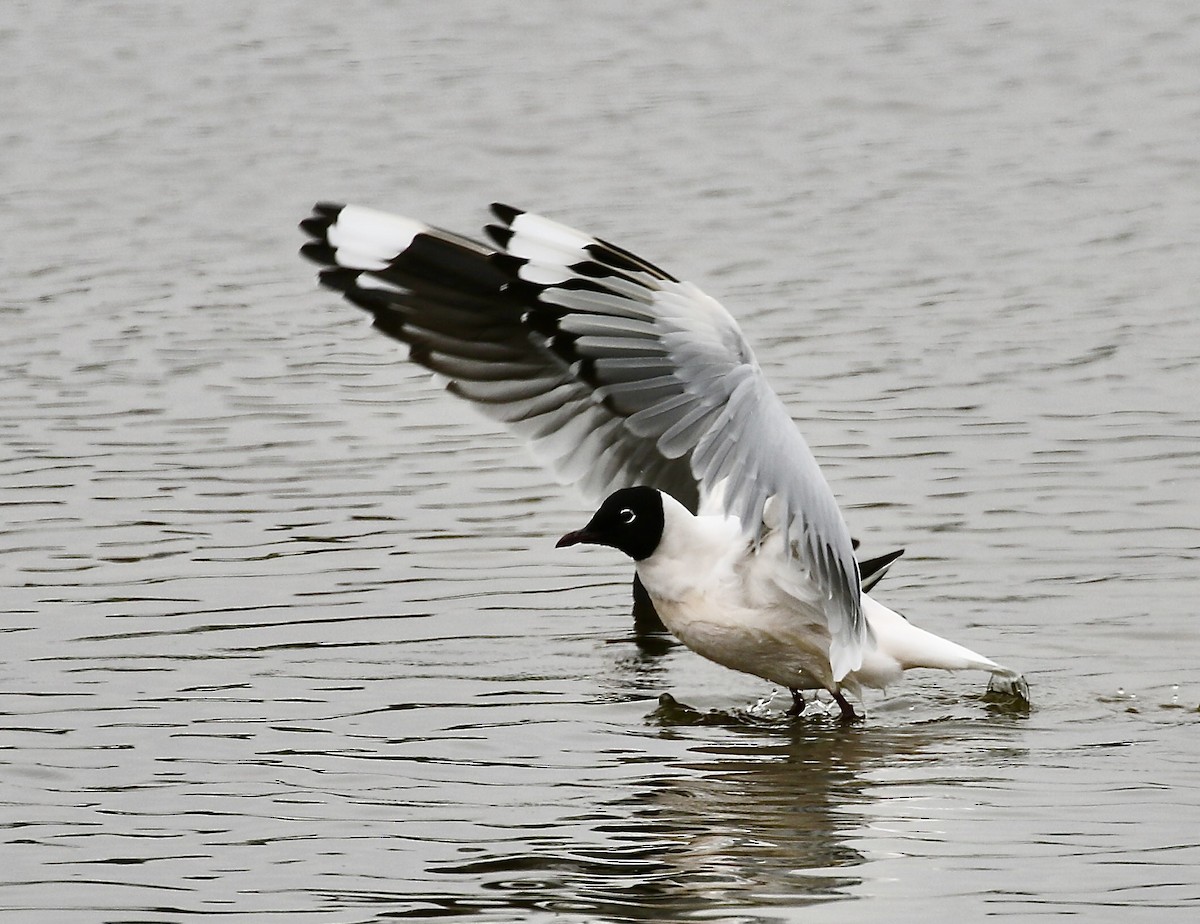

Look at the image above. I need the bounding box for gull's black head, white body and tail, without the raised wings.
[558,486,1024,721]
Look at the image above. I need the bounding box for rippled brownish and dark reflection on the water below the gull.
[422,700,936,920]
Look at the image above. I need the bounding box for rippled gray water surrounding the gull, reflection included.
[0,0,1200,923]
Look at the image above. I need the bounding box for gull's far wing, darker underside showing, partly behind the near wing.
[301,204,700,510]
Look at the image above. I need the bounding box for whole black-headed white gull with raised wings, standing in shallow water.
[300,203,1027,721]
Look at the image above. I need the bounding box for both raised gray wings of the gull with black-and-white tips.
[301,204,869,679]
